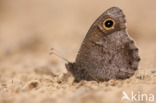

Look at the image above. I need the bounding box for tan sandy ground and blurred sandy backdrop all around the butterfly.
[0,0,156,103]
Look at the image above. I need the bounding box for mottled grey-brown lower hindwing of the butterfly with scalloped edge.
[78,31,140,81]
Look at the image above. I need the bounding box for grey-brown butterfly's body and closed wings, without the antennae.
[66,7,140,81]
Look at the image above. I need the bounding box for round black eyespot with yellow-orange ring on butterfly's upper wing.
[103,18,115,30]
